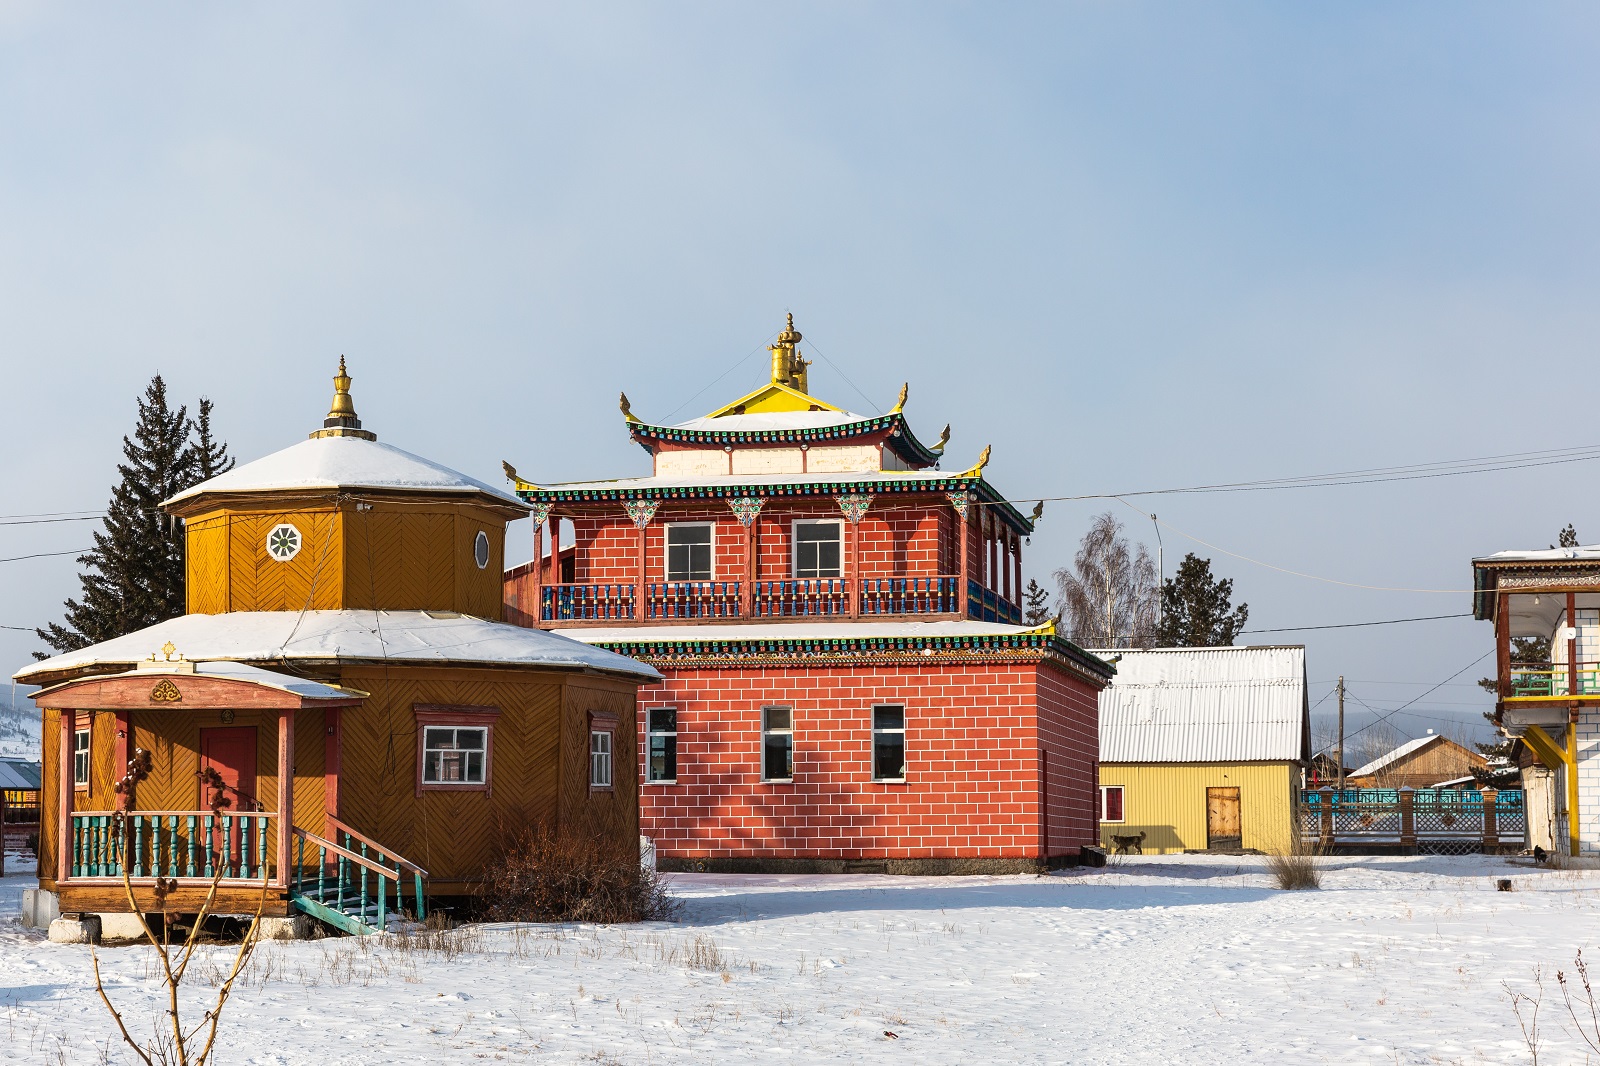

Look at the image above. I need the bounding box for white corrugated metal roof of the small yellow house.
[1091,645,1310,762]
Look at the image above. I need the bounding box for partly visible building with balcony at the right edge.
[1472,546,1600,855]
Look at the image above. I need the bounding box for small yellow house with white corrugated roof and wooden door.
[1096,645,1310,853]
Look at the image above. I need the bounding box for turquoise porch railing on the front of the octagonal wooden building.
[69,810,278,884]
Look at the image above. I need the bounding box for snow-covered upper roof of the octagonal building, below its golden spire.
[163,437,528,511]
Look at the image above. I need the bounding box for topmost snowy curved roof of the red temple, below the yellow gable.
[627,408,939,469]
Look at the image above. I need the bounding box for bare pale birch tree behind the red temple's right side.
[1054,511,1160,648]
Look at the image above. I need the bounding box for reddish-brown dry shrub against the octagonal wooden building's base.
[483,828,680,924]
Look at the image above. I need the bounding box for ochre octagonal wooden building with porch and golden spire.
[16,360,659,933]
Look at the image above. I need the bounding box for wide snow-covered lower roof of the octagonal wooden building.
[14,611,661,682]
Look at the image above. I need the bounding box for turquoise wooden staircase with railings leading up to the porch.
[290,816,427,936]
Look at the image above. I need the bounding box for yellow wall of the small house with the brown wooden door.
[1099,762,1299,855]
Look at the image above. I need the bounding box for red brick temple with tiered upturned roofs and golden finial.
[506,317,1114,872]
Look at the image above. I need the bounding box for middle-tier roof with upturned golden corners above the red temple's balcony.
[517,471,1034,536]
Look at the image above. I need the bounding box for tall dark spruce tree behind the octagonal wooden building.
[35,375,203,658]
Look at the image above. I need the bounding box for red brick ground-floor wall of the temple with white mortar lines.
[638,663,1098,860]
